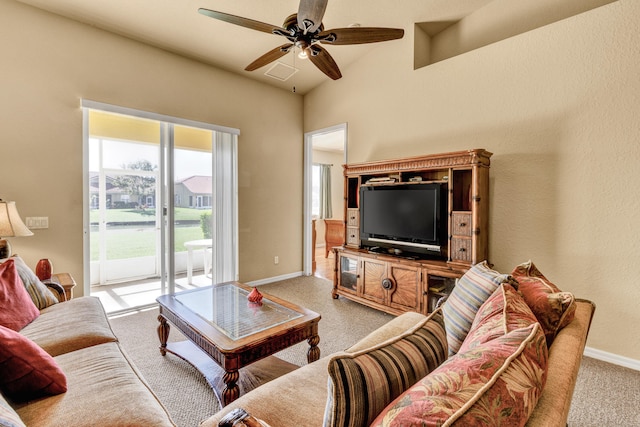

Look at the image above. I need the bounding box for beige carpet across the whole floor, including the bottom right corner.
[111,277,640,427]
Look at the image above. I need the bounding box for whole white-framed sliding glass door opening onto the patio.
[83,101,237,311]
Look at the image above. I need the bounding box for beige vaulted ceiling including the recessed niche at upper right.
[16,0,617,94]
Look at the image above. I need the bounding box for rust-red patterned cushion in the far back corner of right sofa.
[511,260,576,345]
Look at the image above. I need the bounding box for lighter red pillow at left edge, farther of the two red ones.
[0,259,40,331]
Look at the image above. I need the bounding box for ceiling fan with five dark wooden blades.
[198,0,404,80]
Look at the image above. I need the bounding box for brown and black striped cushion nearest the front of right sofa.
[323,310,447,427]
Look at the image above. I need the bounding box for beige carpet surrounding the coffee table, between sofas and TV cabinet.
[111,277,392,427]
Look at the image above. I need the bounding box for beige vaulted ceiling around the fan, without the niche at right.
[17,0,491,94]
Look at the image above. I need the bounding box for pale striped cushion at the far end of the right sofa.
[442,261,517,356]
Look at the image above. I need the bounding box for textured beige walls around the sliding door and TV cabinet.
[0,0,640,360]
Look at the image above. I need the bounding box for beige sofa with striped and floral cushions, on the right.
[201,261,595,427]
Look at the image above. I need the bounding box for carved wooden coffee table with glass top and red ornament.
[156,282,320,406]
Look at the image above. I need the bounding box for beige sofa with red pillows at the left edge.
[0,257,175,427]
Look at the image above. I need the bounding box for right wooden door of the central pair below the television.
[388,264,422,312]
